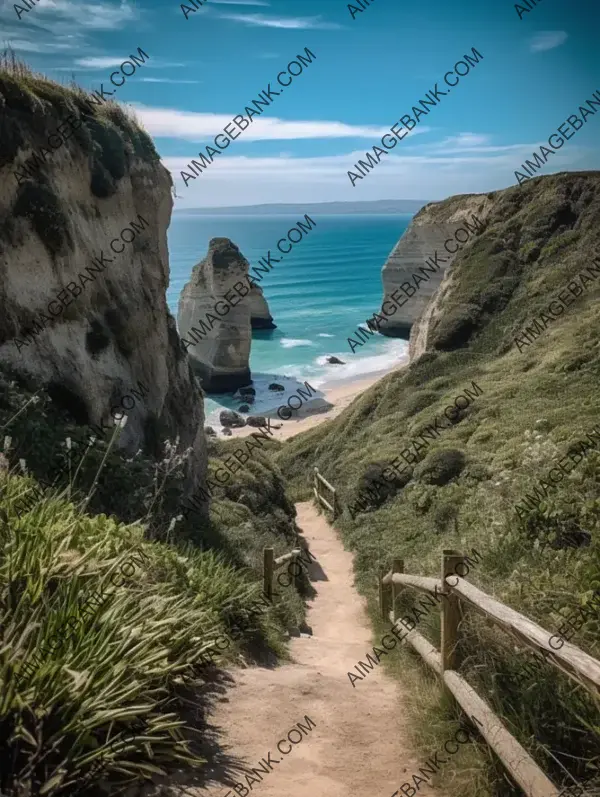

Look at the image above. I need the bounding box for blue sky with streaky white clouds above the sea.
[0,0,600,208]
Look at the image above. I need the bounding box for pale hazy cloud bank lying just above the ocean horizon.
[163,144,600,208]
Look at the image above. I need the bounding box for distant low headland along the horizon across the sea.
[174,199,431,216]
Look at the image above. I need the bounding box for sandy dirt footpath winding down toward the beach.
[182,503,442,797]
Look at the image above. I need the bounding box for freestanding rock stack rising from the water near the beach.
[177,238,274,393]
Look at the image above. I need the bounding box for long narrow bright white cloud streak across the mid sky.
[133,103,430,144]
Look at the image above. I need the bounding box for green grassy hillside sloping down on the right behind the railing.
[277,172,600,797]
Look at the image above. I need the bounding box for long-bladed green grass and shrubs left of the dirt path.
[0,372,304,797]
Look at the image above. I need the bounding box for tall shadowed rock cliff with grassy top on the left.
[0,72,206,504]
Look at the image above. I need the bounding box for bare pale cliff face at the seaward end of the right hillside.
[379,194,492,340]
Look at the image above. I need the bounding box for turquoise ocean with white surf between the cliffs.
[167,211,412,426]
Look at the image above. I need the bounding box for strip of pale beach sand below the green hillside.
[223,357,408,440]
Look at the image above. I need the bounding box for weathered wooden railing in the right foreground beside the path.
[379,550,600,797]
